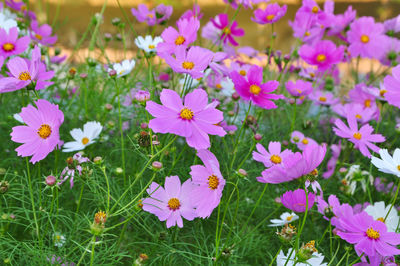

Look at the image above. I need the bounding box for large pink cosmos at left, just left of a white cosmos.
[11,100,64,164]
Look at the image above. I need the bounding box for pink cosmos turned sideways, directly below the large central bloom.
[190,150,225,218]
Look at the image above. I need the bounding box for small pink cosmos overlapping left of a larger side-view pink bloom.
[253,141,293,168]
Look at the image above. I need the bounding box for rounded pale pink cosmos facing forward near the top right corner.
[347,17,385,59]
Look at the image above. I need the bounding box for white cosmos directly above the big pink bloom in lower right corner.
[364,201,399,232]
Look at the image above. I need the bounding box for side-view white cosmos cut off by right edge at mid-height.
[371,148,400,177]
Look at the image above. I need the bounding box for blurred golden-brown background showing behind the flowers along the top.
[24,0,400,60]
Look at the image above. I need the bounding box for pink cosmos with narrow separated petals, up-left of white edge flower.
[333,115,385,158]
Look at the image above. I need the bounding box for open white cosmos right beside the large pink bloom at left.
[63,121,103,152]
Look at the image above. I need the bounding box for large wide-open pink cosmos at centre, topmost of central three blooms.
[146,89,226,150]
